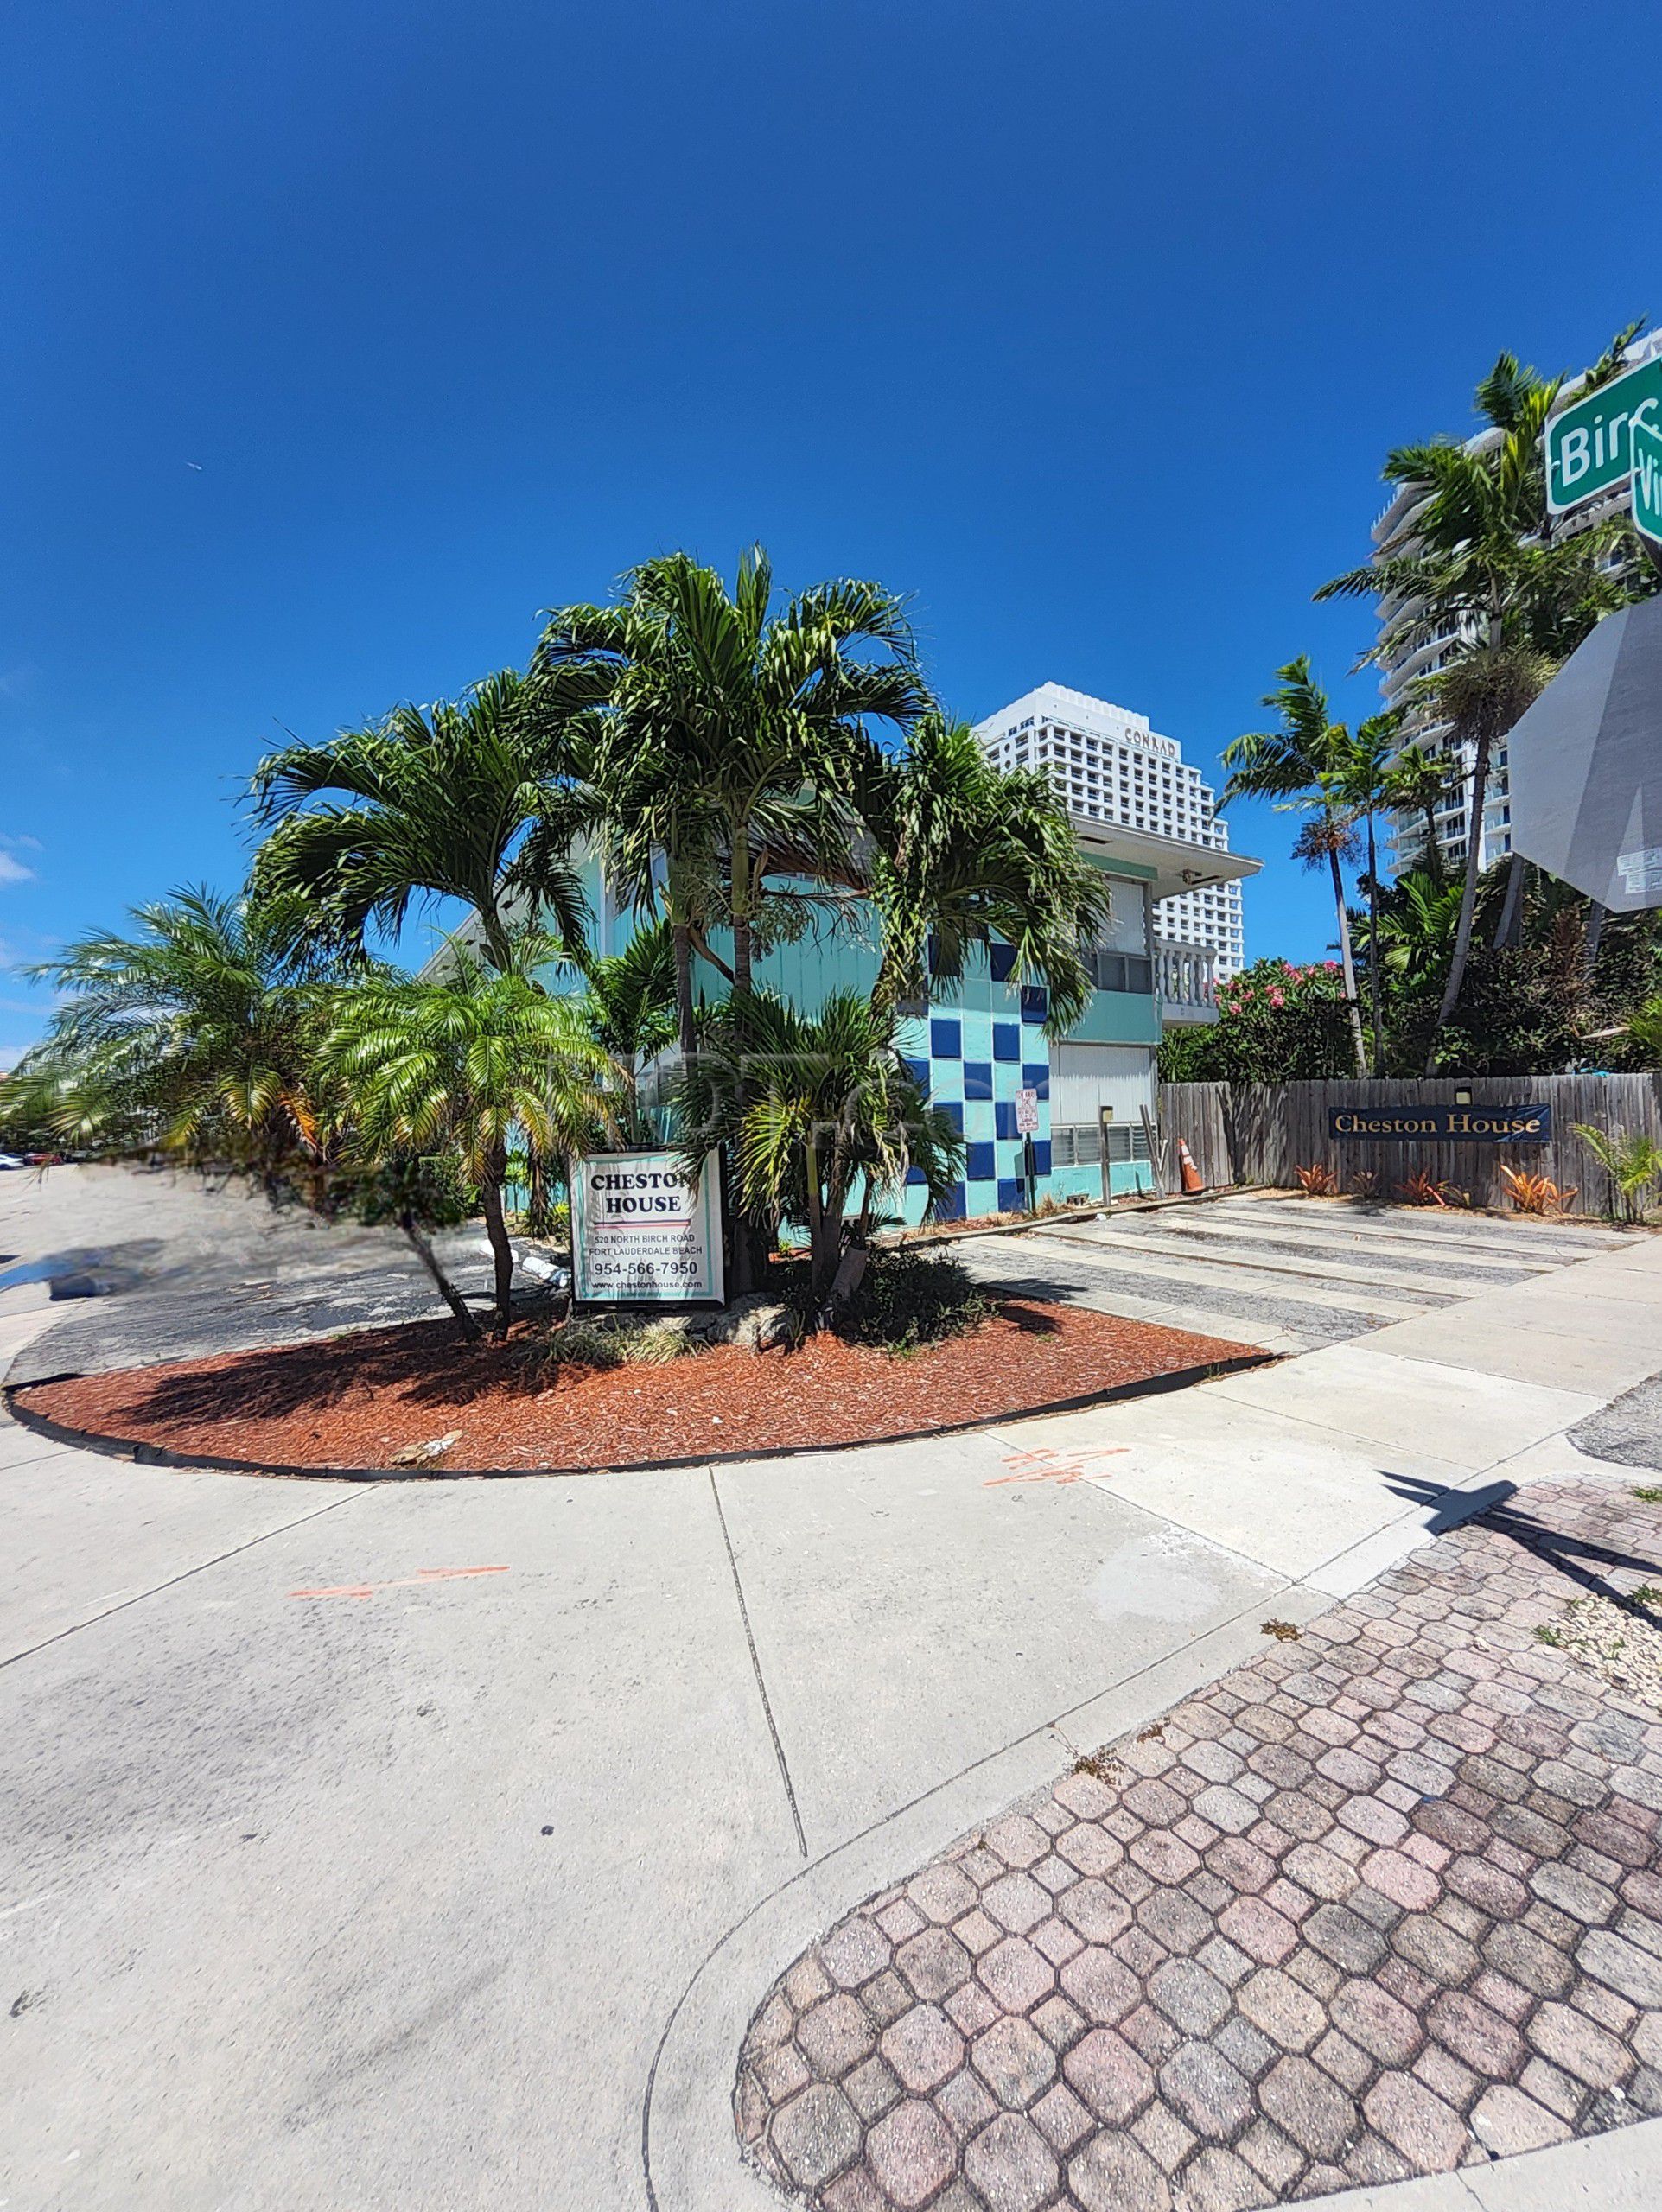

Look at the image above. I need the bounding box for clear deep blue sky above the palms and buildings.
[0,0,1662,1064]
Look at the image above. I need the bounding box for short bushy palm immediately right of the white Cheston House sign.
[675,991,965,1320]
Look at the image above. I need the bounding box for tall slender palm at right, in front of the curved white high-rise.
[1317,336,1653,1075]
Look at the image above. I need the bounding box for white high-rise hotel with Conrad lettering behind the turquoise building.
[976,683,1255,982]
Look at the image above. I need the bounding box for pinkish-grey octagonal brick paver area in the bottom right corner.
[737,1482,1662,2212]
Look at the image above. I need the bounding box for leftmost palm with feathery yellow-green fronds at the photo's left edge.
[7,889,350,1188]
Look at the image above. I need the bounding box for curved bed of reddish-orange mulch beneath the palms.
[17,1299,1252,1473]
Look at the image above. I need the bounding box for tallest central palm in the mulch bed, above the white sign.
[532,546,929,1058]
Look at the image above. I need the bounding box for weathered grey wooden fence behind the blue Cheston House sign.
[1160,1075,1662,1214]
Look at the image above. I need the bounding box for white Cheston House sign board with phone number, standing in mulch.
[571,1153,726,1305]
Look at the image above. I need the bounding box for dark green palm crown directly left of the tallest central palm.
[250,671,593,969]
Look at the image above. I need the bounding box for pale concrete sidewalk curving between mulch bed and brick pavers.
[0,1194,1662,2212]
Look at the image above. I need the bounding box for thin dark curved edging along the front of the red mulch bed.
[3,1351,1283,1482]
